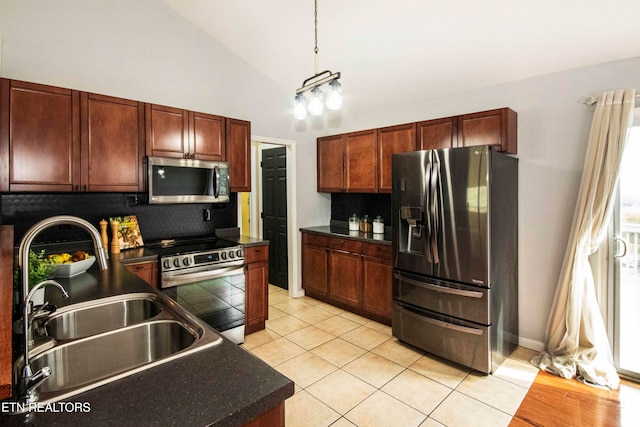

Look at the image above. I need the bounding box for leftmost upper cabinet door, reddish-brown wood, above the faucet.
[0,79,80,191]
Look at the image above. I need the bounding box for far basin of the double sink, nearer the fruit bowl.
[44,293,162,340]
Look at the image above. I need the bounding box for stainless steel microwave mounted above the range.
[147,157,229,204]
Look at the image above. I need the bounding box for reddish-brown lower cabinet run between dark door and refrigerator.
[302,231,392,325]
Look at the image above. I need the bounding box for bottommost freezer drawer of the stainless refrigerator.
[392,302,491,374]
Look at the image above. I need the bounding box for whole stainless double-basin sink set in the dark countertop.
[14,293,222,410]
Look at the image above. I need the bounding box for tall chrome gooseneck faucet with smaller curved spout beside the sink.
[18,215,108,403]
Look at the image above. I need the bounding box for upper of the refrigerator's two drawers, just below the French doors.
[393,271,491,325]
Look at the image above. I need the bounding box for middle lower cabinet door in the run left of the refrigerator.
[329,249,362,309]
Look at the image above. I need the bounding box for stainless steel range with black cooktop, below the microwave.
[147,238,245,344]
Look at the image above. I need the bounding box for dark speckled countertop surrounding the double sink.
[0,255,294,426]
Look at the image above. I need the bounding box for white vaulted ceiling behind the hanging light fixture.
[164,0,640,112]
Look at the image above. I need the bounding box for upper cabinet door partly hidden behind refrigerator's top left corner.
[378,123,416,193]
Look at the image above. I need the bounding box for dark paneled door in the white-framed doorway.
[262,147,288,289]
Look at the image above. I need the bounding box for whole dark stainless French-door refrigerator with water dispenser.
[391,146,518,373]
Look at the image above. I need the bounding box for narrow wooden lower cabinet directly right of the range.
[244,245,269,335]
